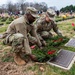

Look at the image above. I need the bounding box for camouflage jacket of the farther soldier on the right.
[36,16,60,35]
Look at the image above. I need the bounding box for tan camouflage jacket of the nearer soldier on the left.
[3,15,41,53]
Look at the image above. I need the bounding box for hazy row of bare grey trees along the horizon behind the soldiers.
[0,0,48,14]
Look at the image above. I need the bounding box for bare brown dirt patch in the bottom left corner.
[0,62,35,75]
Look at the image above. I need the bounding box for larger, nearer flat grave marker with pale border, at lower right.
[47,49,75,70]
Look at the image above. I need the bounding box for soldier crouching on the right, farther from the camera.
[36,9,62,42]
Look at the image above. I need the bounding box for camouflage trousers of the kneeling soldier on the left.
[4,33,35,54]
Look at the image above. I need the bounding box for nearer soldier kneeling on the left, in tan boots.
[2,7,42,65]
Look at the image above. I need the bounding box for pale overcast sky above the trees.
[0,0,75,9]
